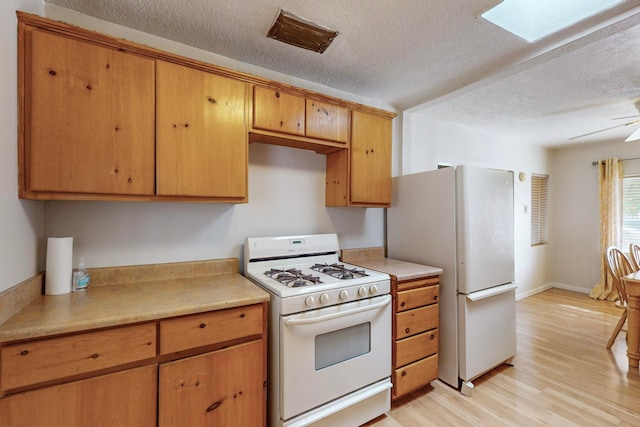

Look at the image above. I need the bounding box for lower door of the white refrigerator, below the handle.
[458,284,516,382]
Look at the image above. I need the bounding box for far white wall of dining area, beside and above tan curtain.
[549,141,640,292]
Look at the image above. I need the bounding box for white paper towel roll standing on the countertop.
[44,237,73,295]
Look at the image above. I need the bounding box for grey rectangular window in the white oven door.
[315,322,371,371]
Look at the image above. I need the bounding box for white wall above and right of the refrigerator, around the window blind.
[401,112,552,298]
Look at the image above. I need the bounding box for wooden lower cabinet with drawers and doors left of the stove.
[0,303,267,427]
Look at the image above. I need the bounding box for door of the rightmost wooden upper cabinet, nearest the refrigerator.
[350,111,391,206]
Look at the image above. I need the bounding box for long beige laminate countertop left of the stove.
[0,273,269,343]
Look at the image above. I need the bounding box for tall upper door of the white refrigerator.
[456,165,515,294]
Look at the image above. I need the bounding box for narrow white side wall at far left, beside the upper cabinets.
[0,0,43,292]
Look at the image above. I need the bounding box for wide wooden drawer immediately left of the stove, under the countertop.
[160,304,263,354]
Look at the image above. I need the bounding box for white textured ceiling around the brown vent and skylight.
[45,0,640,147]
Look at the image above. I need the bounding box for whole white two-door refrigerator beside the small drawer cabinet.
[386,165,516,395]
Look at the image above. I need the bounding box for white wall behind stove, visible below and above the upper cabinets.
[44,5,397,267]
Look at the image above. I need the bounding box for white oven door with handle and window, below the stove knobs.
[280,295,391,420]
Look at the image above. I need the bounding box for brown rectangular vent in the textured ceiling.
[267,9,339,53]
